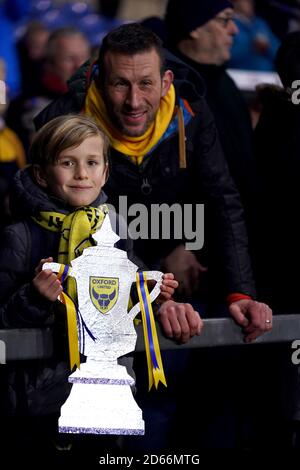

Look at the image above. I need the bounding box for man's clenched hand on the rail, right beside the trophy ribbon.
[157,300,203,343]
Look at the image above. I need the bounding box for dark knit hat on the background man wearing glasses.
[165,0,233,46]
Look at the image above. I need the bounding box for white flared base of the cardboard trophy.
[58,364,145,435]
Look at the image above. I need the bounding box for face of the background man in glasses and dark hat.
[191,8,238,65]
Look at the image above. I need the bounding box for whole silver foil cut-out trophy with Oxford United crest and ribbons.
[43,215,166,434]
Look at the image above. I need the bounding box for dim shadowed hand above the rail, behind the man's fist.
[164,245,207,297]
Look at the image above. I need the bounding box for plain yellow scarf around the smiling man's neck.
[84,81,175,165]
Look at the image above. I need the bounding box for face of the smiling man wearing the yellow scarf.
[102,49,173,137]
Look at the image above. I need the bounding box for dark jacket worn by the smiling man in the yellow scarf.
[35,52,255,296]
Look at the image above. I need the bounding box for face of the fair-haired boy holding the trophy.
[35,136,107,207]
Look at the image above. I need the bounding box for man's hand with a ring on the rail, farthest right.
[229,299,272,343]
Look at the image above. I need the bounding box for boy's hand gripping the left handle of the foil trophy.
[32,258,63,302]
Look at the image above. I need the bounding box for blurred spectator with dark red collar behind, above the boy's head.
[7,27,90,150]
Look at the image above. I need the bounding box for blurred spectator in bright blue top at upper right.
[228,0,279,71]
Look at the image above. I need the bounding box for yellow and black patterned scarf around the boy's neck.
[33,204,108,302]
